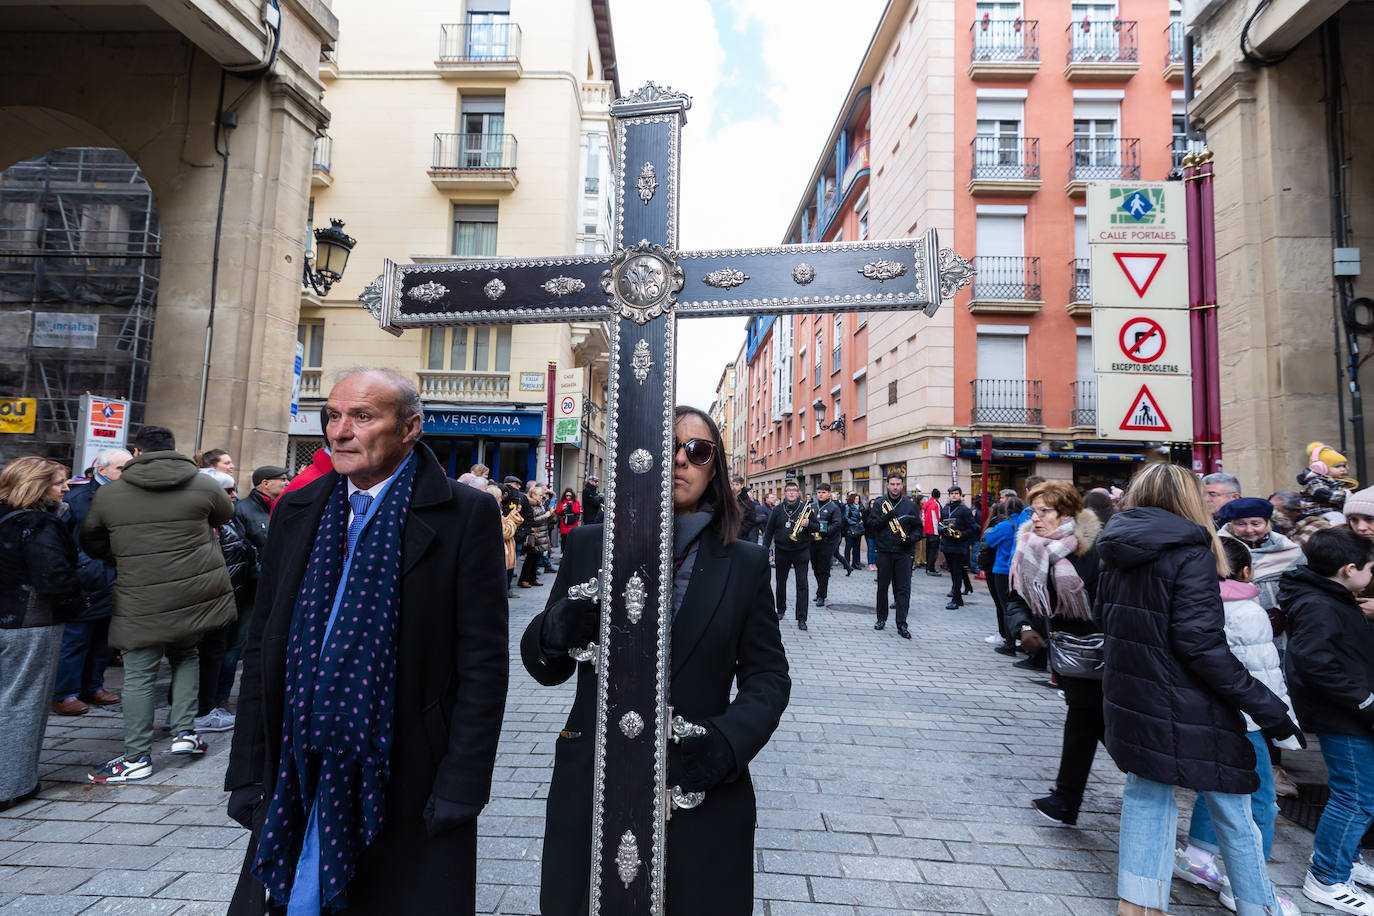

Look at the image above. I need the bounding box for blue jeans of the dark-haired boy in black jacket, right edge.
[1312,735,1374,884]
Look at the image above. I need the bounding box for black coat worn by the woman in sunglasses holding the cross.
[521,525,791,916]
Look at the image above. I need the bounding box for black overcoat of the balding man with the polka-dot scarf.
[224,445,510,916]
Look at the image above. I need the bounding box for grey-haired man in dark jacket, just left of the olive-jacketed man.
[52,449,133,715]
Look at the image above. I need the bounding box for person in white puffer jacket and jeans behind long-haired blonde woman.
[1173,538,1298,906]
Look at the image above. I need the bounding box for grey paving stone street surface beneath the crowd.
[0,570,1319,916]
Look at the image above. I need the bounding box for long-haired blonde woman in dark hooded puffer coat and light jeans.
[1095,464,1301,915]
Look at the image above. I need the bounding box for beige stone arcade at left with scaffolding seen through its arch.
[0,0,338,472]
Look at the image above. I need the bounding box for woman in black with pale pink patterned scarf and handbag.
[1007,481,1103,824]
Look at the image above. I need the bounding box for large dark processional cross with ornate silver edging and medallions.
[360,82,973,916]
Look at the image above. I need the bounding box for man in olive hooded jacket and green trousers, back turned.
[81,426,236,783]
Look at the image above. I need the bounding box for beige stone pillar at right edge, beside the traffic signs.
[1184,0,1374,496]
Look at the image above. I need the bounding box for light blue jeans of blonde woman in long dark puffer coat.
[1117,773,1280,916]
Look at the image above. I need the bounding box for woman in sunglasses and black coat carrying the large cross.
[521,407,791,916]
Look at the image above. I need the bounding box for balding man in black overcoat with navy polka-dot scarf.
[224,369,508,916]
